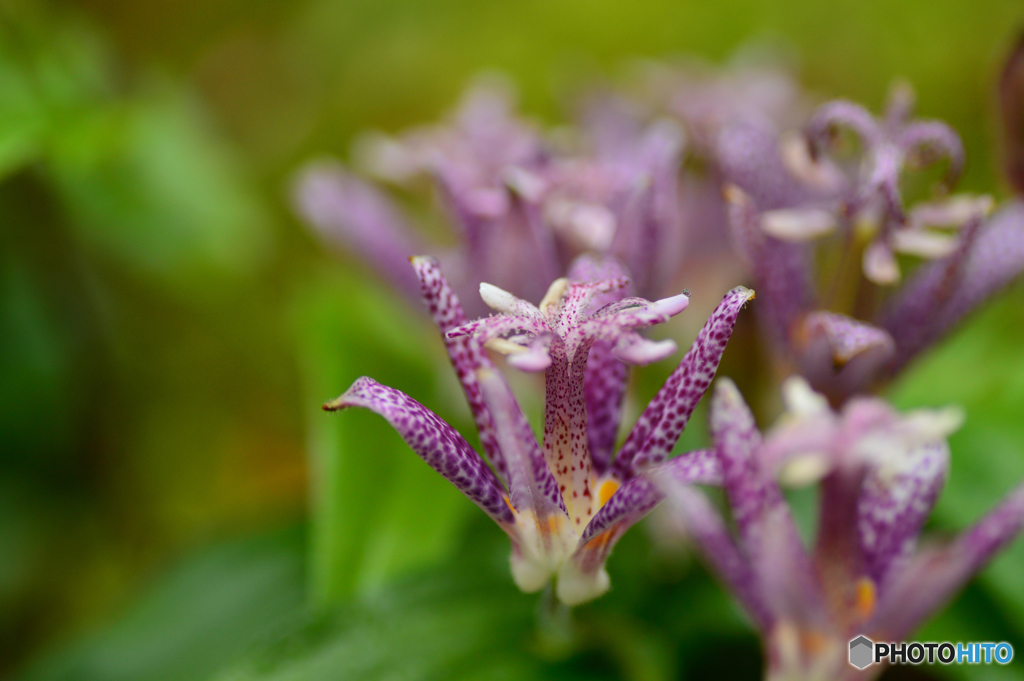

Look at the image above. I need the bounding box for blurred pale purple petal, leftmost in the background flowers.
[295,164,423,300]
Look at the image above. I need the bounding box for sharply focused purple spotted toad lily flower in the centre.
[325,257,753,605]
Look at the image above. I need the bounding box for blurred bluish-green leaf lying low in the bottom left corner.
[22,529,304,681]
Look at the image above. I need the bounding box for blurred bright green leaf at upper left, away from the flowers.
[48,86,270,297]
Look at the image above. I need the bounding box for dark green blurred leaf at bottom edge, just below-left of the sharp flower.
[215,560,538,681]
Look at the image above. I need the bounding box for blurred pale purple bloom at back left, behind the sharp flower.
[294,79,683,312]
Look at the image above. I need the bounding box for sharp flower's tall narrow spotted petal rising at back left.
[412,256,505,481]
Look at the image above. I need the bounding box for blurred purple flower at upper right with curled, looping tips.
[716,81,1024,405]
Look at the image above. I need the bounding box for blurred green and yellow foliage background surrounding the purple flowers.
[6,0,1024,681]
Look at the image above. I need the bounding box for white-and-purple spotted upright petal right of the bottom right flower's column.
[857,442,949,587]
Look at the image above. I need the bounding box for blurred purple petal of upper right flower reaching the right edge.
[880,201,1024,374]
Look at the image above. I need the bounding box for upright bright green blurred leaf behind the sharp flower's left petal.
[295,270,476,602]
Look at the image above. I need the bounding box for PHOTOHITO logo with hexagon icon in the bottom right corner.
[850,636,1014,669]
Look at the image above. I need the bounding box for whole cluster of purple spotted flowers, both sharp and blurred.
[296,45,1024,678]
